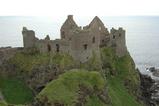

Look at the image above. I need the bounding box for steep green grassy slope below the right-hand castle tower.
[102,48,141,106]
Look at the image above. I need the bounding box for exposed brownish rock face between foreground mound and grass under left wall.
[27,65,62,92]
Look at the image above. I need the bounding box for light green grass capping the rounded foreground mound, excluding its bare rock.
[37,70,105,106]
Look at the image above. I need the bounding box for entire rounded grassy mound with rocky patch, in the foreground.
[37,69,106,106]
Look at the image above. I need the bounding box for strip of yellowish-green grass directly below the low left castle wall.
[8,52,75,73]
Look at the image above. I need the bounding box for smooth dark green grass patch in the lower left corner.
[0,77,33,104]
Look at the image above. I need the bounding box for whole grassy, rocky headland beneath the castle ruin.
[0,48,142,106]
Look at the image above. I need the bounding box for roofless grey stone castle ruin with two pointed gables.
[22,15,127,63]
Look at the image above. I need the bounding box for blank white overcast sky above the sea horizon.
[0,0,159,17]
